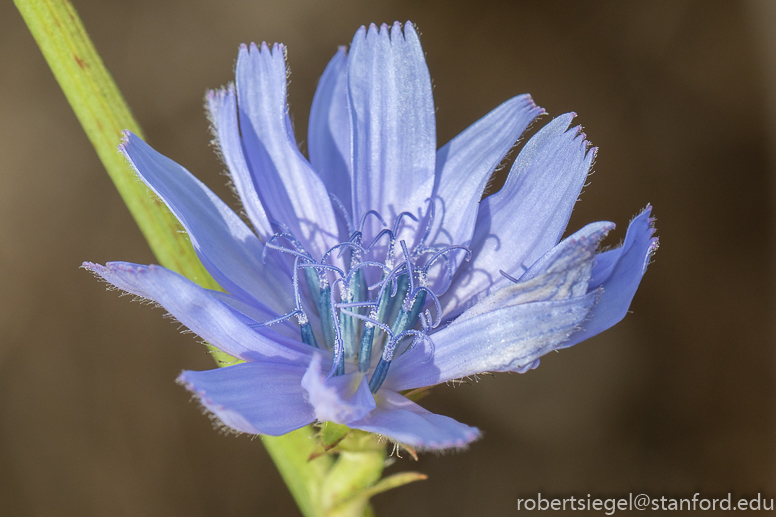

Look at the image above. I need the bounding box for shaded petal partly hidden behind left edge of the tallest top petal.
[307,47,353,218]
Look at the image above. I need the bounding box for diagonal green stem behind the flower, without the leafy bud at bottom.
[14,0,324,517]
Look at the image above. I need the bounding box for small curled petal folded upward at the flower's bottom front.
[302,354,375,425]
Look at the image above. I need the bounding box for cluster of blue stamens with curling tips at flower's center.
[253,205,470,393]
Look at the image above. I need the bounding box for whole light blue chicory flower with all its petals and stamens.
[85,23,657,449]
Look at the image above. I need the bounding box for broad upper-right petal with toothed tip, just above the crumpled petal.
[444,114,595,316]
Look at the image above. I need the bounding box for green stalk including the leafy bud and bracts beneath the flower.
[14,0,410,517]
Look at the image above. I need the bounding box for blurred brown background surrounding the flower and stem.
[0,0,776,517]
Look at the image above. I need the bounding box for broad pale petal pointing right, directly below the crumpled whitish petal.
[384,292,599,391]
